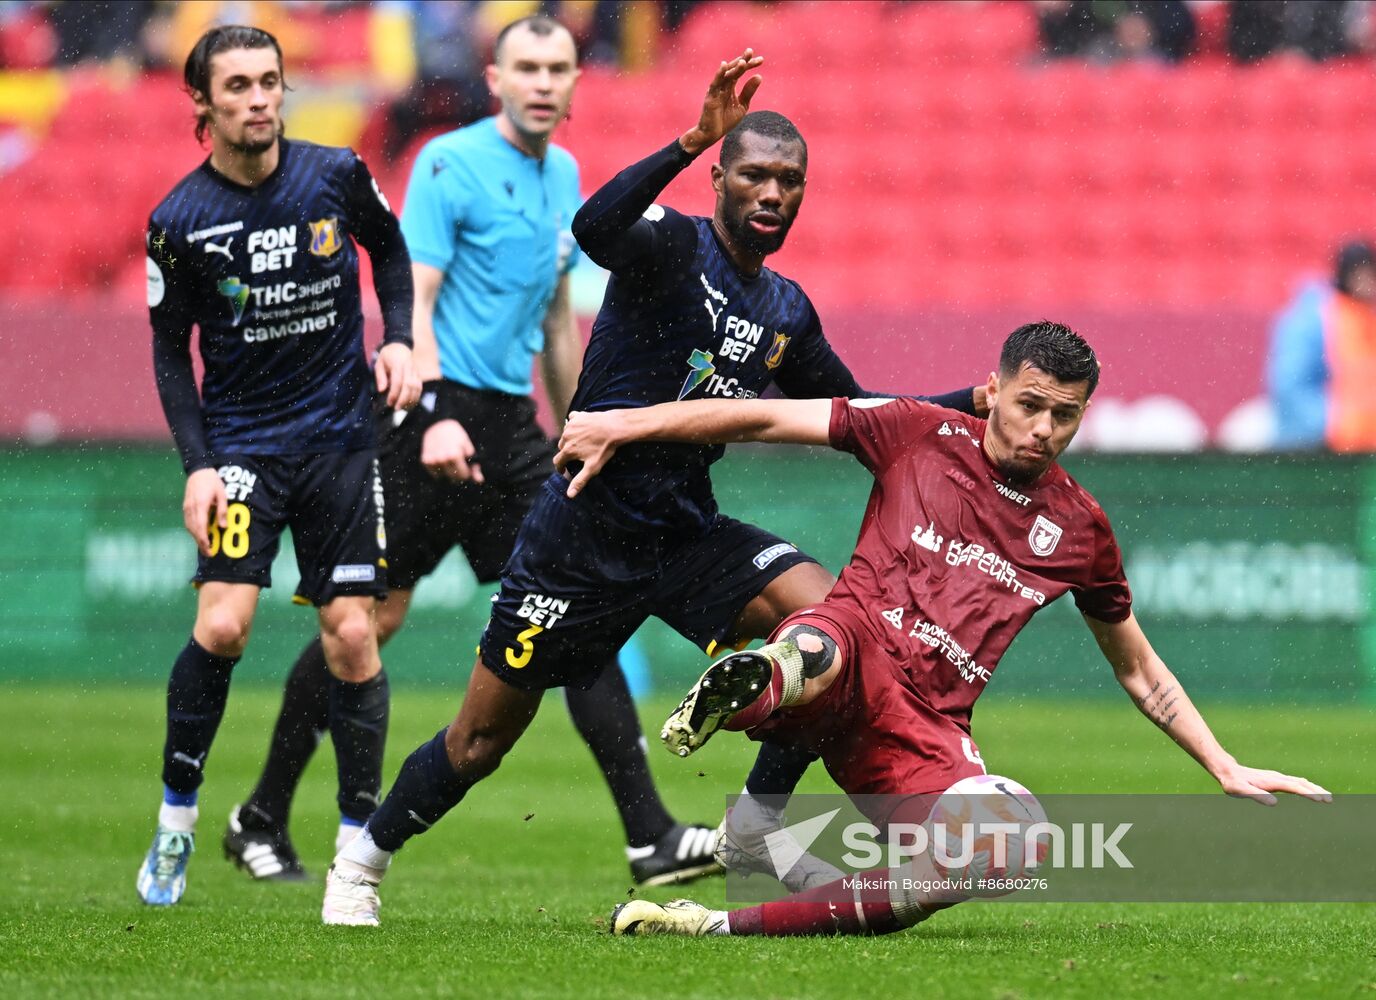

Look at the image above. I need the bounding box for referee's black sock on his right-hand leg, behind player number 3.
[564,663,674,847]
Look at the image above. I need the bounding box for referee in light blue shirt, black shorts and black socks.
[232,15,717,884]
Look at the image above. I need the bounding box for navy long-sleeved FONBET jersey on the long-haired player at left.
[147,140,411,470]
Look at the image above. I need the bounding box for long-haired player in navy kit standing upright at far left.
[138,26,420,905]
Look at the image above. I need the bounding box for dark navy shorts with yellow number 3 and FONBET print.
[479,475,816,691]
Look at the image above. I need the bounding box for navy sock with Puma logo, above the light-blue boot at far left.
[162,638,239,795]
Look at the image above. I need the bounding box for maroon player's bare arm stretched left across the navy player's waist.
[555,399,831,497]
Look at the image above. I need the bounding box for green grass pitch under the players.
[0,678,1376,1000]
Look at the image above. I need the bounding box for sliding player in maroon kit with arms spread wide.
[556,322,1331,935]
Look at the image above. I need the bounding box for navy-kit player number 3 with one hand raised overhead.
[322,46,973,926]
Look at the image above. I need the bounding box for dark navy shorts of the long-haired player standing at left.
[194,450,387,605]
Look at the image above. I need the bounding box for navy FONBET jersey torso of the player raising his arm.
[571,205,860,528]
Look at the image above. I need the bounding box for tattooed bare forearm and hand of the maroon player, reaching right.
[1084,613,1333,806]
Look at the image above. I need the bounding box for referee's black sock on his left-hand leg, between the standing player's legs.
[241,635,330,827]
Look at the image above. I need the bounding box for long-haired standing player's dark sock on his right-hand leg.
[330,670,391,825]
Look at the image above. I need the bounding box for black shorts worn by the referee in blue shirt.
[378,385,555,590]
